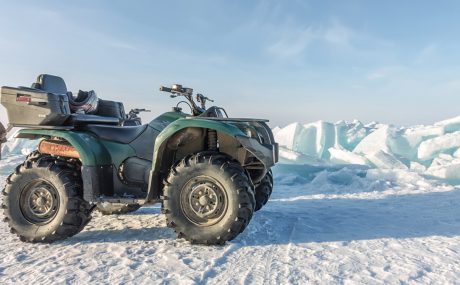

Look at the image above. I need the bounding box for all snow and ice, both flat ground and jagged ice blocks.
[0,119,460,284]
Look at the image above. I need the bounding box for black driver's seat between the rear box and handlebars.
[81,125,147,144]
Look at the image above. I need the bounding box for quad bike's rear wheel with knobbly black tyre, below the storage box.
[2,155,91,242]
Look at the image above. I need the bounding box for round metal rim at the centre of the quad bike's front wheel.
[181,176,228,226]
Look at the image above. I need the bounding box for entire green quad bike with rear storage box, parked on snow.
[1,74,278,244]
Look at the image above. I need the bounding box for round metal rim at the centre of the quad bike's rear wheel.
[20,180,59,224]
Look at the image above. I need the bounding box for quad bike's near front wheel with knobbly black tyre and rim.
[162,152,254,245]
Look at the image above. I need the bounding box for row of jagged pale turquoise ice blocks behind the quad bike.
[274,116,460,184]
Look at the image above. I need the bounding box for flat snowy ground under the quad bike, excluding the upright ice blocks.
[0,156,460,284]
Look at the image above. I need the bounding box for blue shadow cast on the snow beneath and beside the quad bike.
[59,163,460,246]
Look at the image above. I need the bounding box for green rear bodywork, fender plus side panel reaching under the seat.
[16,129,135,166]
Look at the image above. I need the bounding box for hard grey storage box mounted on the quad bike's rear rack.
[1,86,70,126]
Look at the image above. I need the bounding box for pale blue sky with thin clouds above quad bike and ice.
[0,0,460,126]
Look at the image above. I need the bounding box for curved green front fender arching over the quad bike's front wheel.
[152,117,246,172]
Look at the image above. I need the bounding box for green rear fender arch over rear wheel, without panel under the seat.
[16,129,112,166]
